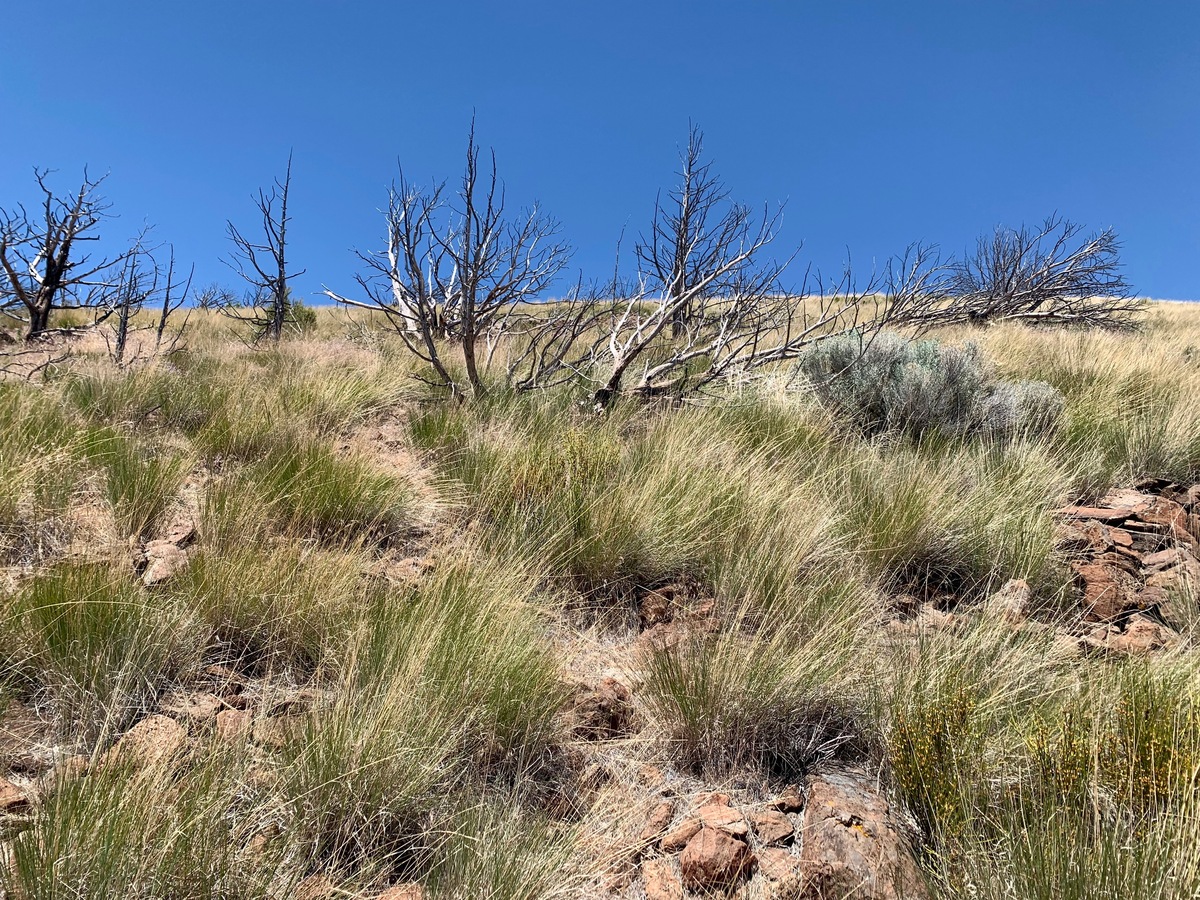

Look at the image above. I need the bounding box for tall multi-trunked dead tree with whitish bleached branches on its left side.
[325,122,570,397]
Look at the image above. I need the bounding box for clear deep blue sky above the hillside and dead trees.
[0,0,1200,299]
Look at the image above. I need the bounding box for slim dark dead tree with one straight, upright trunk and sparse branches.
[222,154,304,342]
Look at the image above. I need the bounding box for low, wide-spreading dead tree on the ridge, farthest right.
[902,215,1144,329]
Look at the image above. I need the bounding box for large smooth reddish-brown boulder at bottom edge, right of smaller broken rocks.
[800,769,926,900]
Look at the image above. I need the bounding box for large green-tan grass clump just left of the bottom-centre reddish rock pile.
[282,560,563,883]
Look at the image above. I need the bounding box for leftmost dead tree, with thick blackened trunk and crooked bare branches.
[0,169,127,341]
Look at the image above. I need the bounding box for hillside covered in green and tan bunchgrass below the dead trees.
[0,280,1200,900]
